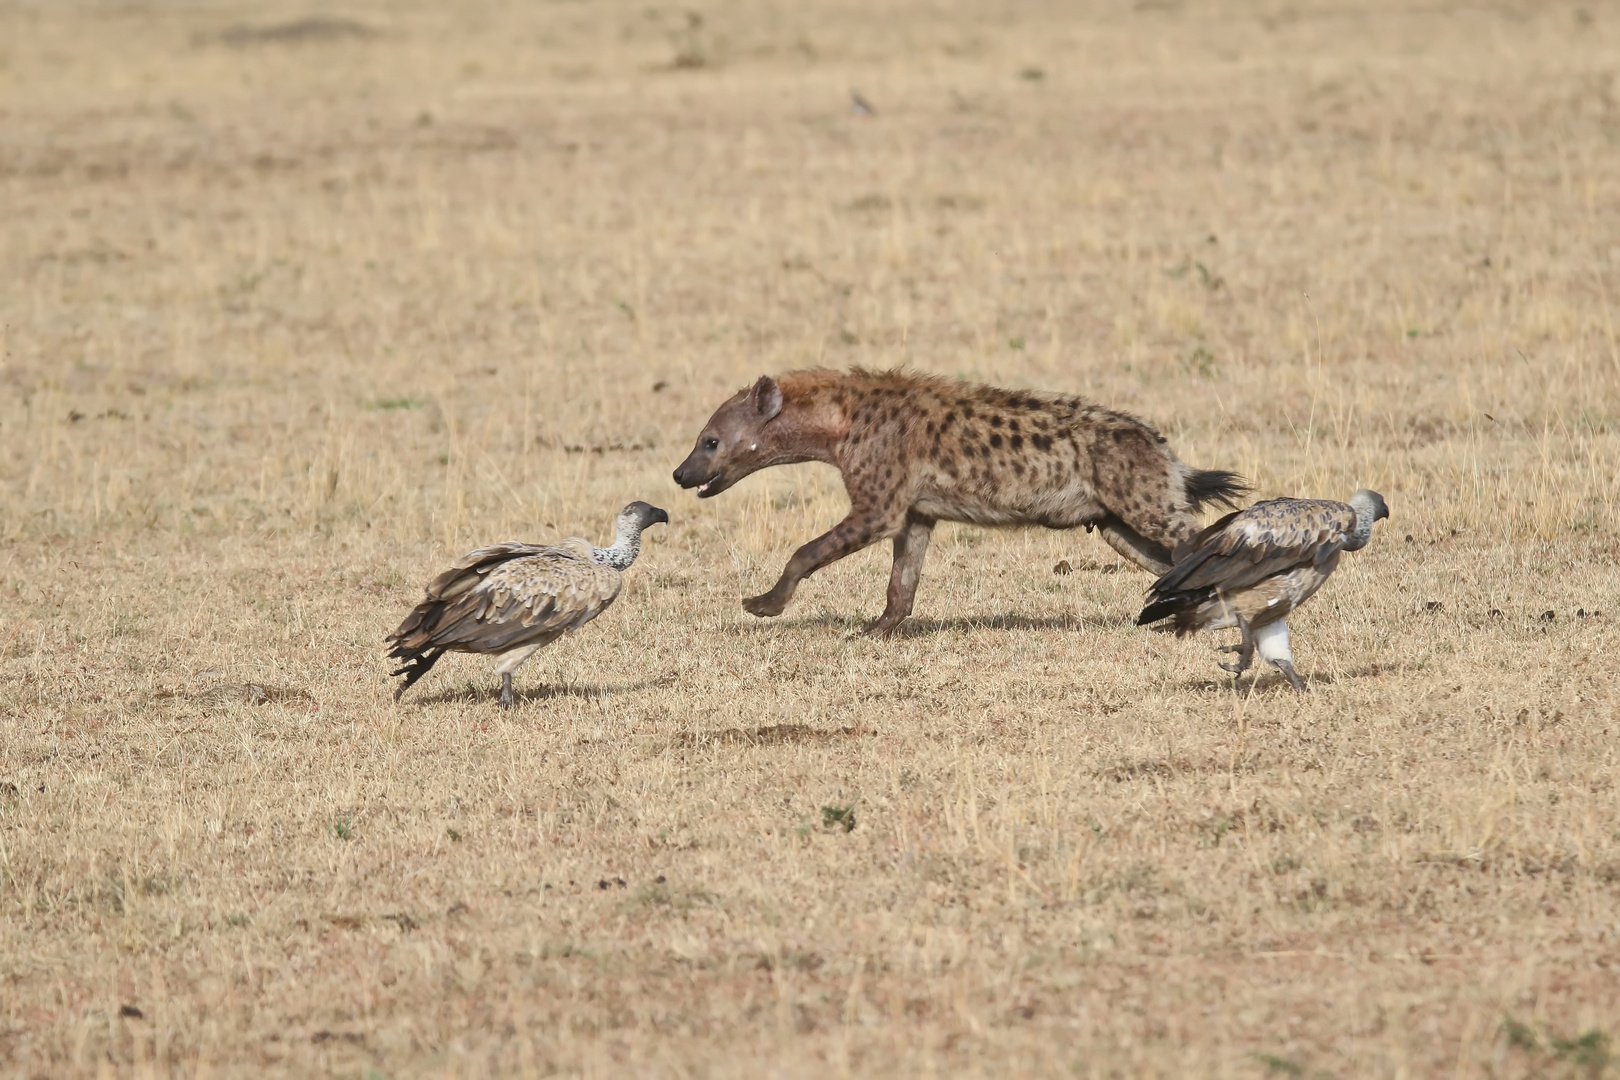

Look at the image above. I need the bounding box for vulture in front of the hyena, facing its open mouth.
[387,502,669,709]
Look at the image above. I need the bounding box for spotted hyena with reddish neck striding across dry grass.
[676,369,1247,635]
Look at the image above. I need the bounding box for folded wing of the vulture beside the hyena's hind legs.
[1153,499,1356,596]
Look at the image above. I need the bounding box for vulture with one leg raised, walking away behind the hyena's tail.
[1136,489,1390,690]
